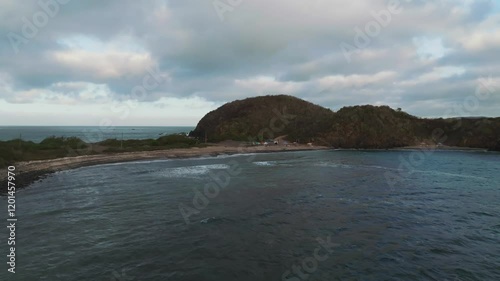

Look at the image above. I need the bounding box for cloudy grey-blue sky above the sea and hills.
[0,0,500,126]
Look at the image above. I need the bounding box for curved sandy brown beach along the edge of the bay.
[0,143,331,196]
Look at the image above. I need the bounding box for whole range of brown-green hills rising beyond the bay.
[190,95,500,151]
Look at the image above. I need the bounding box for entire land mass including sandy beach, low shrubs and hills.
[0,95,500,192]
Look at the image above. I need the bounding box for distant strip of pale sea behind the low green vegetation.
[0,126,194,143]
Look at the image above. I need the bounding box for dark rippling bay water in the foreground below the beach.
[0,151,500,281]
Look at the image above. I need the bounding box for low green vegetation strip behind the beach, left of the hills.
[0,135,199,168]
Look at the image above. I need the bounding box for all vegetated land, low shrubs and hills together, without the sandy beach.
[0,95,500,167]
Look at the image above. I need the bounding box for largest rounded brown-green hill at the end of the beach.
[190,95,333,142]
